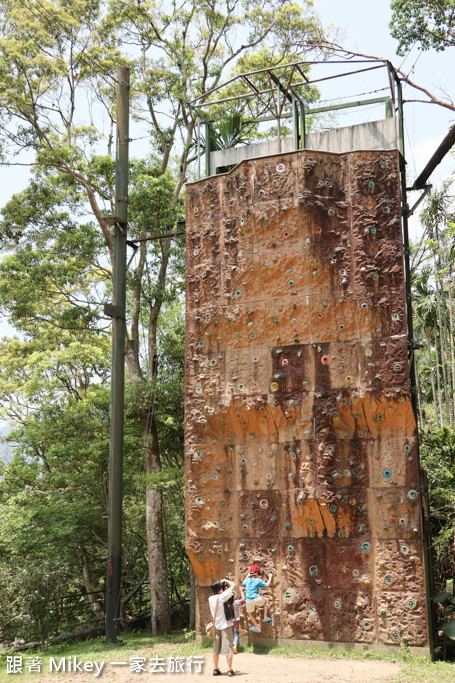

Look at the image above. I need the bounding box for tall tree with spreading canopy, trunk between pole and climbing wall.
[0,0,321,633]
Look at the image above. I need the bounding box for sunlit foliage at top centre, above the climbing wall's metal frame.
[107,0,321,107]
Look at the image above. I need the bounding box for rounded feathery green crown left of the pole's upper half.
[0,173,108,341]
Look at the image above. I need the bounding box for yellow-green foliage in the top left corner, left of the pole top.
[0,0,120,167]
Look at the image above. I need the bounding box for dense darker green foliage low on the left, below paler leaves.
[0,387,109,640]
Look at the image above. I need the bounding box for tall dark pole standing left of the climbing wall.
[104,68,130,643]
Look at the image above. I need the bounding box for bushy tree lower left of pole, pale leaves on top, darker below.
[0,323,113,640]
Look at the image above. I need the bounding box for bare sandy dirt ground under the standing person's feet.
[34,652,400,683]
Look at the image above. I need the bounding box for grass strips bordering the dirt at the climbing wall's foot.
[0,631,455,683]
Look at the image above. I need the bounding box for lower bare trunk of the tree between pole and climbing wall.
[142,416,171,635]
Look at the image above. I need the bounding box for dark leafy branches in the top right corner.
[390,0,455,55]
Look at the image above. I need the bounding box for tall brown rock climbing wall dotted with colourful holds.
[185,151,428,646]
